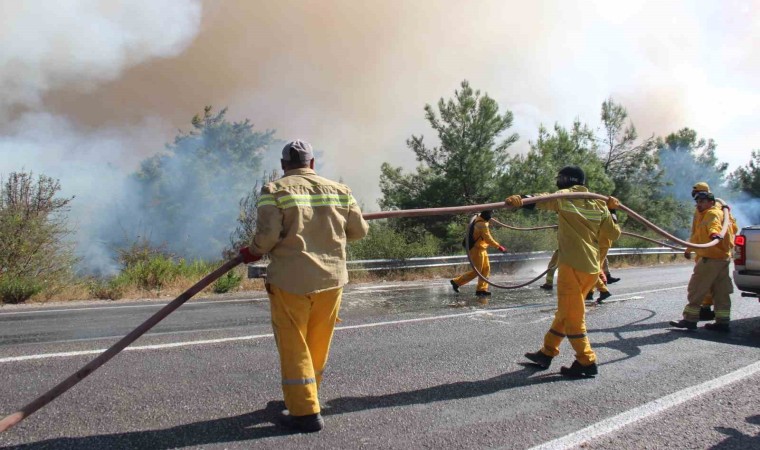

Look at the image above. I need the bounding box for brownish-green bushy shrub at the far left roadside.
[0,172,76,302]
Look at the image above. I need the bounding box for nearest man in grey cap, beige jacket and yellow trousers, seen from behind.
[240,140,369,432]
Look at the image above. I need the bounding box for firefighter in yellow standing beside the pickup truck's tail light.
[670,191,737,332]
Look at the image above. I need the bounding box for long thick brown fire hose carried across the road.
[0,193,729,432]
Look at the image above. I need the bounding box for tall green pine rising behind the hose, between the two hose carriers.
[379,80,518,237]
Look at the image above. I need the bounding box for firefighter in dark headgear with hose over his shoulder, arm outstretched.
[505,166,620,378]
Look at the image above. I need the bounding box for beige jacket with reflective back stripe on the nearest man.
[251,168,369,294]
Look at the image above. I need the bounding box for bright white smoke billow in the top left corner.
[0,0,201,112]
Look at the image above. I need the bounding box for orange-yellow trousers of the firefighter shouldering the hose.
[541,263,599,366]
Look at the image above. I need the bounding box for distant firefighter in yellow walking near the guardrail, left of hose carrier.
[449,211,507,297]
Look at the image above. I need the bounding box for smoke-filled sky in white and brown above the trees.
[0,0,760,266]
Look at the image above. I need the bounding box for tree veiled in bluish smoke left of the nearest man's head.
[126,106,276,258]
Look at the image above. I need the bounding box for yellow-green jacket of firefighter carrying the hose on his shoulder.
[536,186,620,273]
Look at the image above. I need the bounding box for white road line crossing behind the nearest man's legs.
[0,286,686,364]
